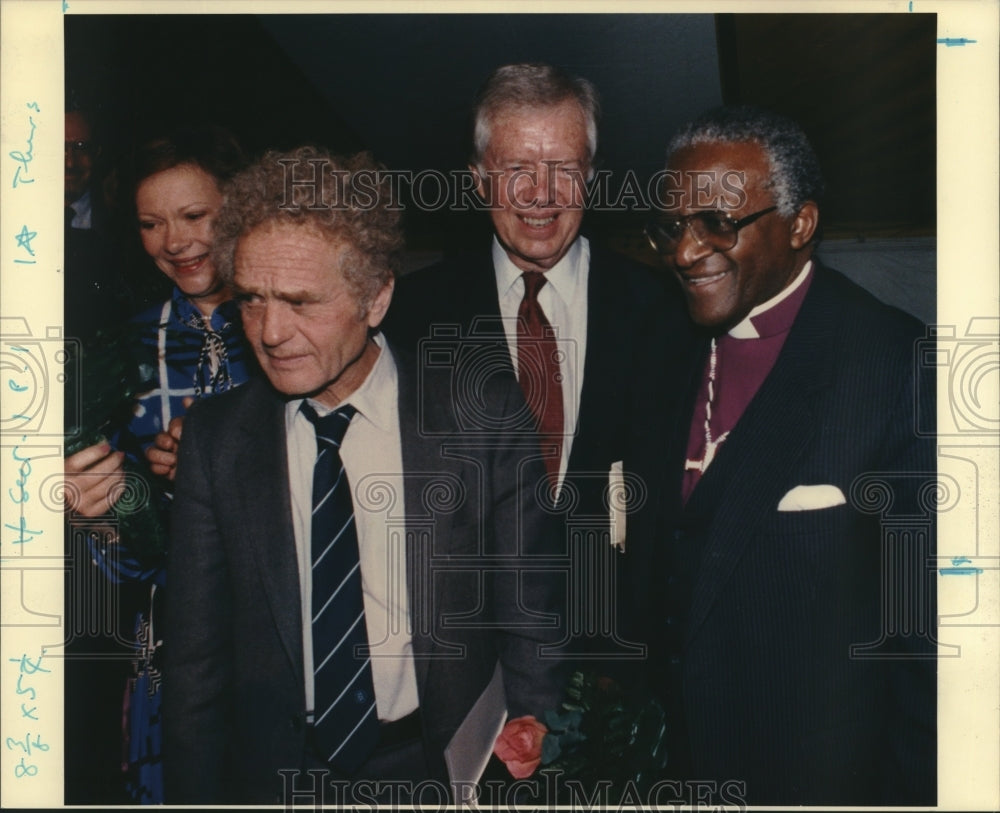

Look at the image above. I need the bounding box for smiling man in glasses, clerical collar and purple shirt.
[626,108,936,805]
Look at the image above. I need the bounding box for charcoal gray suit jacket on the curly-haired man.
[164,342,562,804]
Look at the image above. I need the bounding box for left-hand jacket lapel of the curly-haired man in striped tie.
[233,380,302,676]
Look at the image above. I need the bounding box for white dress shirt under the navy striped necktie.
[285,335,419,721]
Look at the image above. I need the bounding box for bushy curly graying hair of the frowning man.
[212,147,403,313]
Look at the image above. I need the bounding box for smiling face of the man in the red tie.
[471,101,590,271]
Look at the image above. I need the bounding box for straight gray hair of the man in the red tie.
[472,62,601,171]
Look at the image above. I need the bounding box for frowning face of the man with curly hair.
[233,223,392,407]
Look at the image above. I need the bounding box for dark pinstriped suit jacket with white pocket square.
[626,268,936,805]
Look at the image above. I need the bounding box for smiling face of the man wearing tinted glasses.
[661,142,812,330]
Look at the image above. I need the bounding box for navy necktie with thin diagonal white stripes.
[302,401,379,774]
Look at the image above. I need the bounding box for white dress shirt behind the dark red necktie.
[493,237,590,483]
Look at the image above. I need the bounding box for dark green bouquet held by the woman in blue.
[65,326,167,563]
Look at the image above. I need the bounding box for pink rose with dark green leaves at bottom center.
[494,672,667,799]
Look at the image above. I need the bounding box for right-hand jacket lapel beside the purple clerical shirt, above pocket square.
[674,269,842,640]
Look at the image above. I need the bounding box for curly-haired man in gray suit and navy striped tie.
[164,148,562,804]
